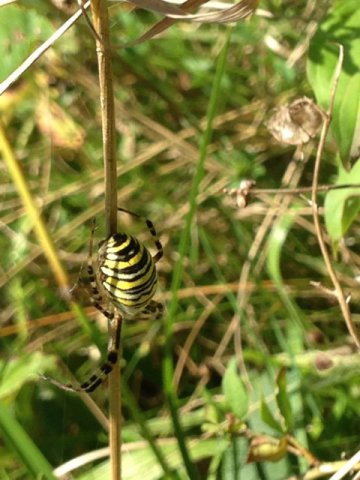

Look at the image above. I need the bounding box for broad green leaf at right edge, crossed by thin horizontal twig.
[324,160,360,248]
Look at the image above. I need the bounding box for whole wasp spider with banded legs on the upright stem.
[42,208,163,393]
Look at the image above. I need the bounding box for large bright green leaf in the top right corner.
[307,0,360,163]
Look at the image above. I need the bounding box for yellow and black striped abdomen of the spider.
[98,233,157,317]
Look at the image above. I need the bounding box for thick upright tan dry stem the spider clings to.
[90,0,121,480]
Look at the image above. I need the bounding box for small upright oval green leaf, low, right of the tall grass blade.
[222,358,249,420]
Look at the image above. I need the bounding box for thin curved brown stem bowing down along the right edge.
[311,45,360,348]
